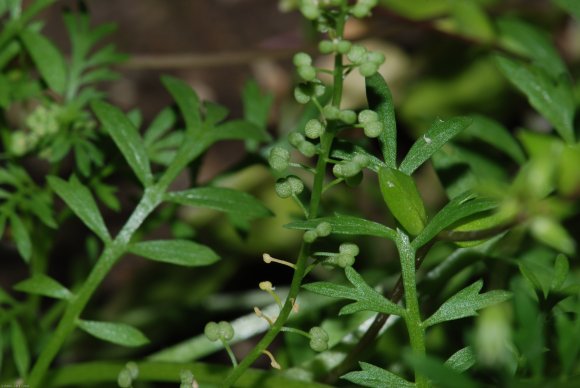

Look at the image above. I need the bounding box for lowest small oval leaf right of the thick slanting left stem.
[77,319,149,347]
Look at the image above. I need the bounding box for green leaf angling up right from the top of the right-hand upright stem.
[412,192,498,250]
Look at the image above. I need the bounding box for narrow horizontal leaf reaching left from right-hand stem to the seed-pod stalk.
[284,215,397,240]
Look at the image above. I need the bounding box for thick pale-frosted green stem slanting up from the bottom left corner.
[28,186,165,387]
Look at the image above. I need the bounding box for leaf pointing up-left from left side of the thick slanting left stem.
[47,175,111,241]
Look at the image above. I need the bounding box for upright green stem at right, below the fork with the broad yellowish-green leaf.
[396,233,429,388]
